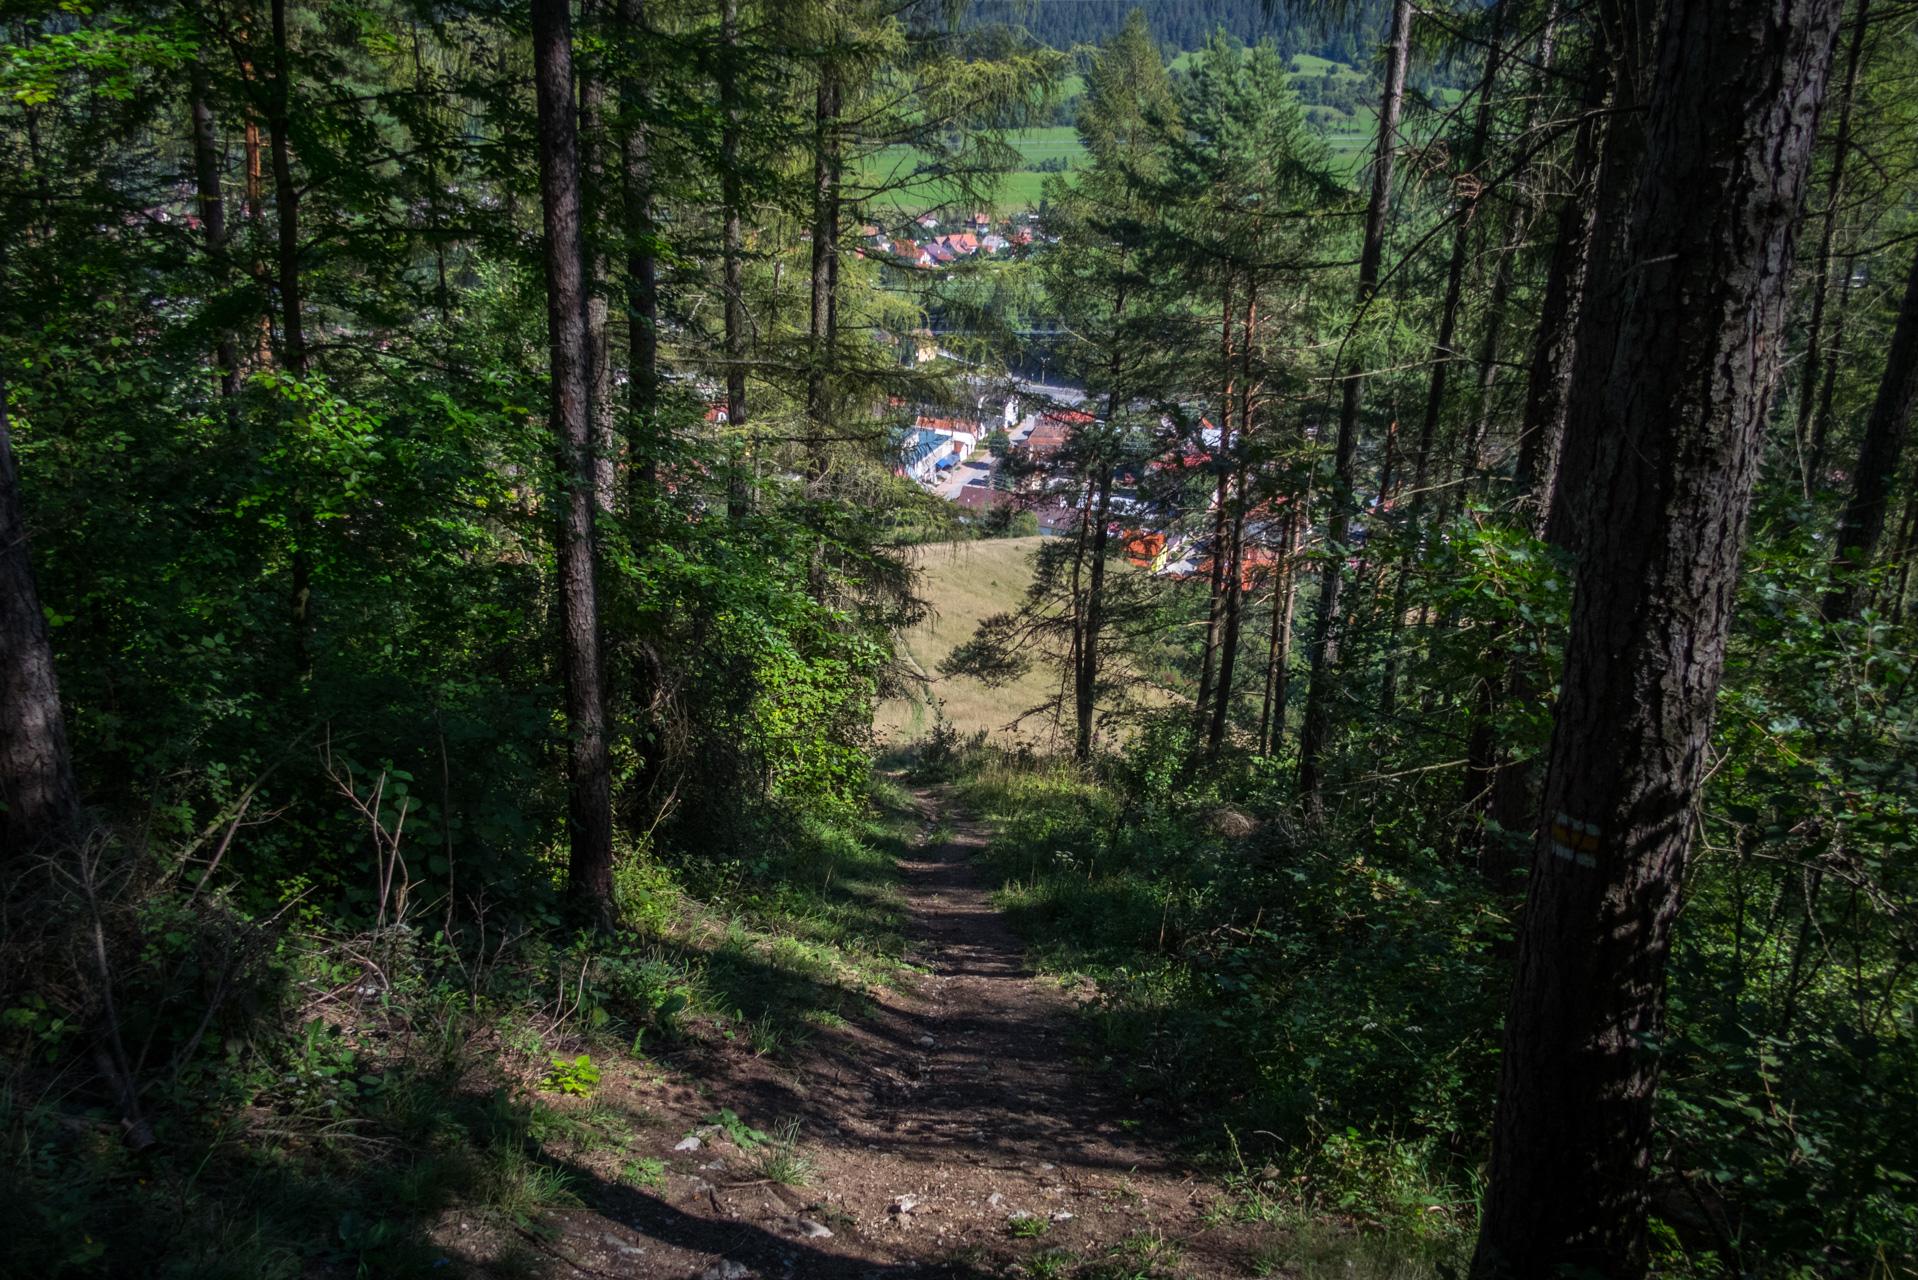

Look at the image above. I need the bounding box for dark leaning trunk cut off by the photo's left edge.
[0,360,81,854]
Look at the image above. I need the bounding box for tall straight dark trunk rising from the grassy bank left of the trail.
[533,0,612,912]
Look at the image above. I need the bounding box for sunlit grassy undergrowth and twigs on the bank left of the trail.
[0,779,928,1280]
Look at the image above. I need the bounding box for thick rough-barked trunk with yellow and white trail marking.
[1473,0,1839,1280]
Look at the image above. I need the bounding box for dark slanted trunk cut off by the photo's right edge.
[1822,239,1918,622]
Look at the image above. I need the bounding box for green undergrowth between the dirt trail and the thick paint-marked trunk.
[944,729,1506,1276]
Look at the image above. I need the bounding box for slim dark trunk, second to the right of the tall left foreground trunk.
[620,0,660,487]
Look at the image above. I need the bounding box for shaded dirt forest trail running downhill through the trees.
[473,789,1262,1280]
